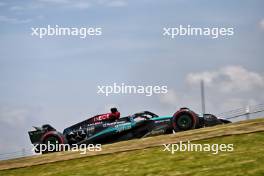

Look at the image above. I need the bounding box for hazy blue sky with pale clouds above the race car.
[0,0,264,153]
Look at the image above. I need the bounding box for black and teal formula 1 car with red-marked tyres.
[28,108,230,152]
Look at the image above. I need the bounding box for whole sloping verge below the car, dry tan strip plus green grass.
[0,119,264,176]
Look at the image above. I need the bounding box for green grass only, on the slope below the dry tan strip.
[0,132,264,176]
